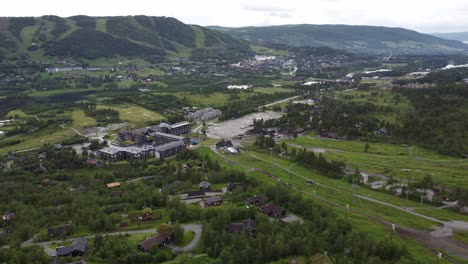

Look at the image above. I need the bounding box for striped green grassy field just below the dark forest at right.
[288,137,468,187]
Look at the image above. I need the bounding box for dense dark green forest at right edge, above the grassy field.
[394,84,468,156]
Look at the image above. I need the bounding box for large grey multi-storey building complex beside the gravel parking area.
[98,122,191,162]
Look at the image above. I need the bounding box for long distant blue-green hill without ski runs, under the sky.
[209,25,468,54]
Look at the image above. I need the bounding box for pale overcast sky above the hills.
[0,0,468,33]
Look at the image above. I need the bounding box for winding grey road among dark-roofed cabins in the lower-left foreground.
[21,224,203,257]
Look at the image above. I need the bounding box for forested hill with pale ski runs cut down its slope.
[0,16,251,61]
